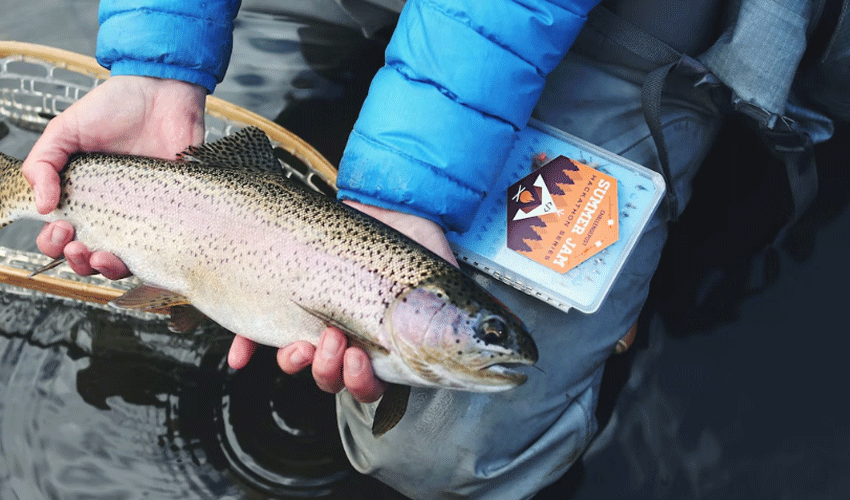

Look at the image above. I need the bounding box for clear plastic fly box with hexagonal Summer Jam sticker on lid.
[447,120,664,313]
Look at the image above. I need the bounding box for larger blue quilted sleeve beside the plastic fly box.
[338,0,598,231]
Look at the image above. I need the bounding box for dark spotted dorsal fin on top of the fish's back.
[177,126,283,175]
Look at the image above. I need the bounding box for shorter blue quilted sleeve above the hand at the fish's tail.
[97,0,240,92]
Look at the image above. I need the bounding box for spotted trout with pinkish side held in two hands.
[0,127,538,436]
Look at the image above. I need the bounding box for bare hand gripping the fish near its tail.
[23,76,206,279]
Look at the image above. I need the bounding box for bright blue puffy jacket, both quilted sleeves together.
[97,0,598,231]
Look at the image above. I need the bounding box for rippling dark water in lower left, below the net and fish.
[0,294,357,499]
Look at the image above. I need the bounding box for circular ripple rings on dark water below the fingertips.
[219,350,349,496]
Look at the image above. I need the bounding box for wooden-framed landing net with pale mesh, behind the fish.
[0,41,336,311]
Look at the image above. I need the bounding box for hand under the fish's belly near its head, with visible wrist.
[228,201,457,403]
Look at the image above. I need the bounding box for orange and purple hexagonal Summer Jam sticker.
[508,156,620,273]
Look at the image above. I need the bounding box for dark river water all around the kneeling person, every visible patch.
[0,0,850,500]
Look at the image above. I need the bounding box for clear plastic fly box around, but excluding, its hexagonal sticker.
[447,120,665,313]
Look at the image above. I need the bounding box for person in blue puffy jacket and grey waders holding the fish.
[19,0,836,499]
